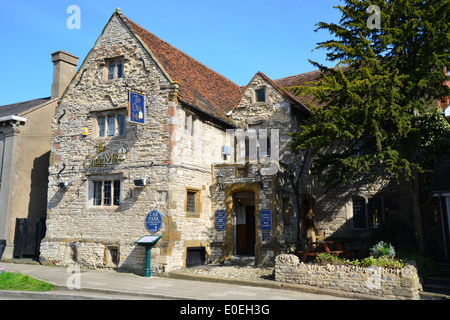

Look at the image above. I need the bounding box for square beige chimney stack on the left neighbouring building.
[51,51,78,99]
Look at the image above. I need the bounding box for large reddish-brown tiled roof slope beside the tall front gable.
[117,13,241,120]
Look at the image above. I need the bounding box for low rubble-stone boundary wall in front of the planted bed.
[275,254,422,300]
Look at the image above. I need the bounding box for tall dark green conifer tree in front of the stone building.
[288,0,450,248]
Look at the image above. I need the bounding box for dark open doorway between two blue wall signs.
[233,191,256,256]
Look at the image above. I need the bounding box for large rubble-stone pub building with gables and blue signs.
[40,10,414,272]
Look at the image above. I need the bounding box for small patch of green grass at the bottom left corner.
[0,272,53,292]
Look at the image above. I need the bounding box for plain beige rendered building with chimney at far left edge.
[0,51,78,259]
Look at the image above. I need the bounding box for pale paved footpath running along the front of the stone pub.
[0,262,369,301]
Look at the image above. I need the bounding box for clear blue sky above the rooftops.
[0,0,340,105]
